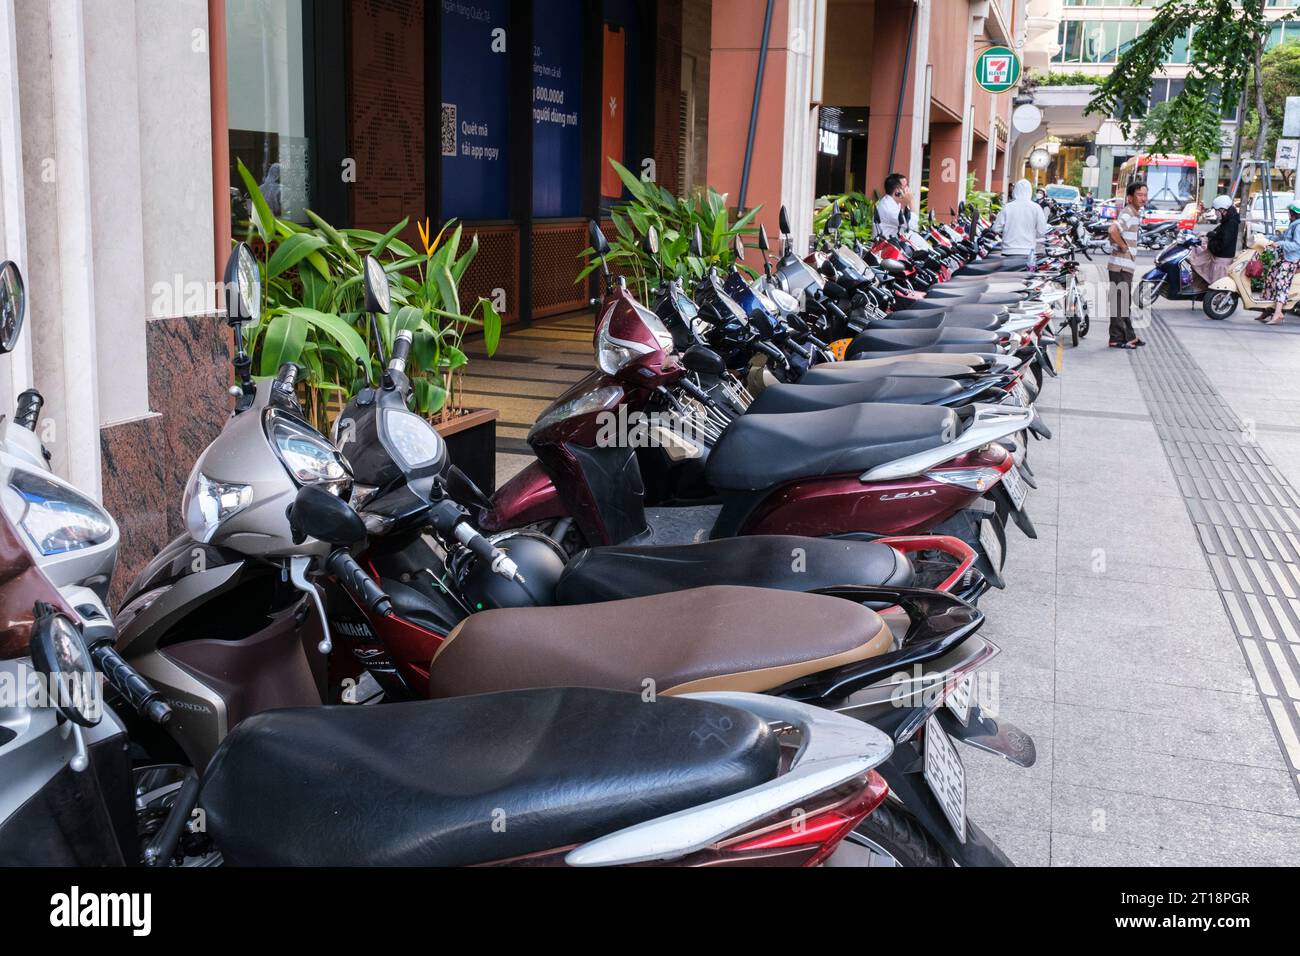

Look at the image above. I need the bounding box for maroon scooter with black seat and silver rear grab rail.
[484,224,1035,587]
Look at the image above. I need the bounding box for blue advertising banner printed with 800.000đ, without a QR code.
[533,0,582,219]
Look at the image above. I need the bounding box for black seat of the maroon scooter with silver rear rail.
[705,405,961,492]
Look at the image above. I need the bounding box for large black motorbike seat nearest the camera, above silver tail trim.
[200,688,780,866]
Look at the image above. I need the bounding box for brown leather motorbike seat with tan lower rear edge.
[429,587,893,697]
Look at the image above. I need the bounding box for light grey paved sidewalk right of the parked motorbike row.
[962,282,1300,865]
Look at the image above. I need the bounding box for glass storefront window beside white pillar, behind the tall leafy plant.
[226,0,313,222]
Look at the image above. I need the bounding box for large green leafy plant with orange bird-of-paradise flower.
[238,161,501,431]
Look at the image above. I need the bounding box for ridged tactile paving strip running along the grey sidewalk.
[1132,312,1300,790]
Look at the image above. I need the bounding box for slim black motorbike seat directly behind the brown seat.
[555,535,914,605]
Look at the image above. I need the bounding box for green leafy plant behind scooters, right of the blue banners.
[575,159,763,302]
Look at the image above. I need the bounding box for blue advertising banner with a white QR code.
[439,0,512,220]
